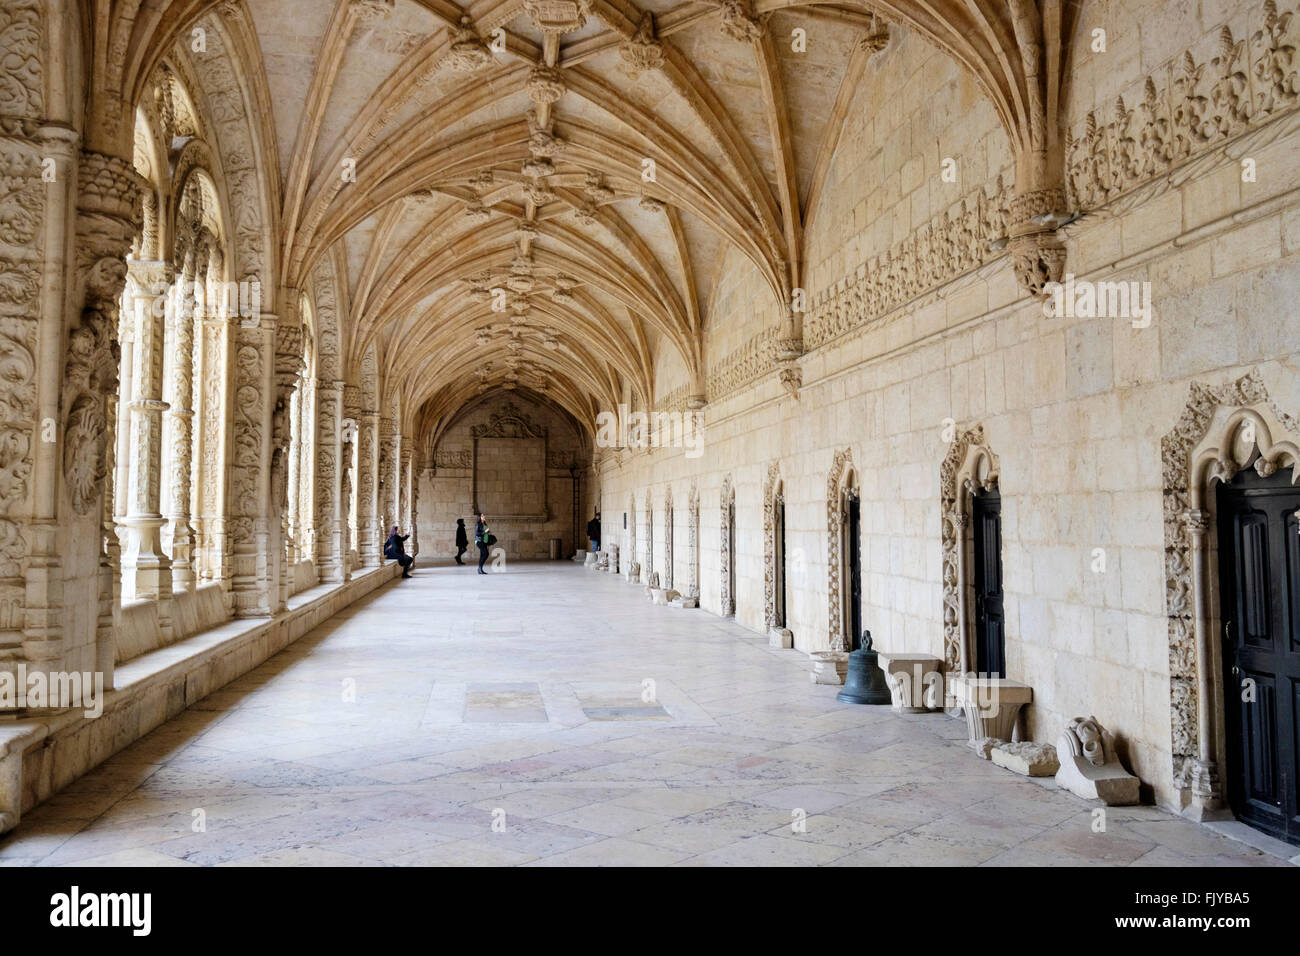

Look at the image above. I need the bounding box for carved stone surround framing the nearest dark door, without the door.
[1160,369,1300,810]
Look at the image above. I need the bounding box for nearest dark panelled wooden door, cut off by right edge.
[1217,468,1300,844]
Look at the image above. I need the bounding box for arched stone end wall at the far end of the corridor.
[416,393,592,561]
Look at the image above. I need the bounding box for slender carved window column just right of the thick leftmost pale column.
[166,246,207,591]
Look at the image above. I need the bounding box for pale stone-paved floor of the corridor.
[0,562,1286,866]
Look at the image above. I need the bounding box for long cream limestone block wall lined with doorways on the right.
[601,4,1300,805]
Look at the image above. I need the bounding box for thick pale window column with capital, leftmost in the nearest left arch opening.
[122,259,172,616]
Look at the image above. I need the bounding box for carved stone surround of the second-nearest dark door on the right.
[939,424,998,674]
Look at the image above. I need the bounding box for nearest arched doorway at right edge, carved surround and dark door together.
[1161,371,1300,843]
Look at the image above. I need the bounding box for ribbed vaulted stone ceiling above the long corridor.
[87,0,1069,439]
